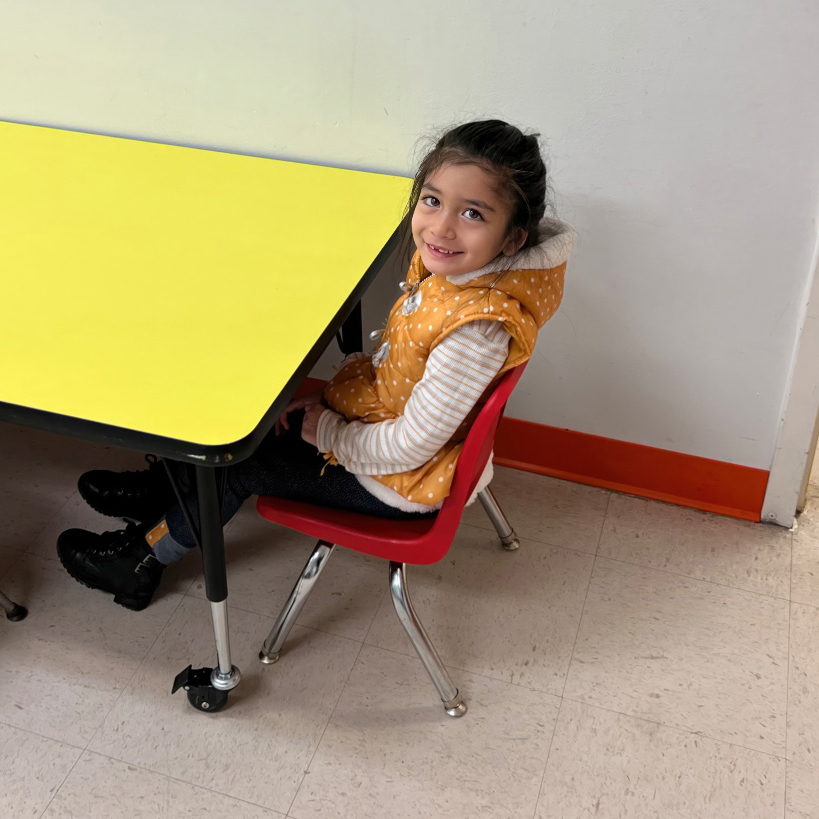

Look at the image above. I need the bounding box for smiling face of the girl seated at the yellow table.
[412,164,526,276]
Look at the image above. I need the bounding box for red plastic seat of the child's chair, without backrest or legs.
[256,497,448,566]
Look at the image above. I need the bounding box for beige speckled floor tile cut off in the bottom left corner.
[0,723,82,819]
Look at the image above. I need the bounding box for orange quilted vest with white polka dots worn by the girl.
[324,237,566,504]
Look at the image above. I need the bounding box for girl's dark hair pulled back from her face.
[407,119,547,247]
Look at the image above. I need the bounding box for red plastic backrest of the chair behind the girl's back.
[436,362,526,540]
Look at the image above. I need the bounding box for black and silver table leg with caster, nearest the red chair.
[173,466,241,712]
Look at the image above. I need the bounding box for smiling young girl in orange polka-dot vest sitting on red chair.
[57,120,573,610]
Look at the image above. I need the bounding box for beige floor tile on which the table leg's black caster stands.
[89,597,361,813]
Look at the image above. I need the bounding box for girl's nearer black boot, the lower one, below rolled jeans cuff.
[57,523,165,611]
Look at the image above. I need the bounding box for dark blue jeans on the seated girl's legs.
[165,412,436,548]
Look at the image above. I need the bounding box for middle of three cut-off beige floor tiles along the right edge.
[788,603,819,768]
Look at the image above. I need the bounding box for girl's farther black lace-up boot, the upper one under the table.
[77,455,180,522]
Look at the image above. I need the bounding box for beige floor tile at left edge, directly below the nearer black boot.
[0,554,182,747]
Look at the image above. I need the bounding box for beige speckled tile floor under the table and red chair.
[0,425,819,819]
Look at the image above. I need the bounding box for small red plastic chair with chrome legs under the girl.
[257,364,526,717]
